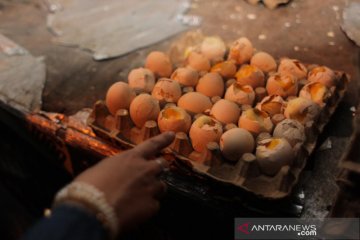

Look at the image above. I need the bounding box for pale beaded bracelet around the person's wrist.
[53,182,119,239]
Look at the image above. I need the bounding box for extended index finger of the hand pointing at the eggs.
[133,132,175,157]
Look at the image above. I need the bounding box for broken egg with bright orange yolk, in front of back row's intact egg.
[236,64,265,89]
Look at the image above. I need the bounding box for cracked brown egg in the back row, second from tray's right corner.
[278,58,307,80]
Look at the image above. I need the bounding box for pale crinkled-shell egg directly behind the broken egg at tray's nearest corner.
[273,119,306,147]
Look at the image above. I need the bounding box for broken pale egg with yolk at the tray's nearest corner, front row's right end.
[256,138,294,176]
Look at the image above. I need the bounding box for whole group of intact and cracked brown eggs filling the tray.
[106,37,336,175]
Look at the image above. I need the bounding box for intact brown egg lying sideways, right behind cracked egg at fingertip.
[178,92,212,115]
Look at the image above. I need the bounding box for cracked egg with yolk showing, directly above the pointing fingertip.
[158,106,191,133]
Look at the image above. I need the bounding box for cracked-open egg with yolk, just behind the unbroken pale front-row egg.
[239,108,274,136]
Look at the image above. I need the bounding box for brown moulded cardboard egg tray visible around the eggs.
[88,72,349,200]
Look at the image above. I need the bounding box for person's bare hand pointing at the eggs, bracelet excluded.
[75,132,175,230]
